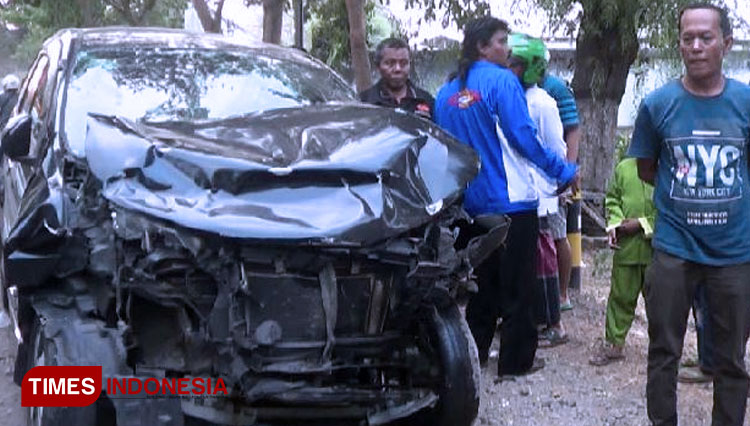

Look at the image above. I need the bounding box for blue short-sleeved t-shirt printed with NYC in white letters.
[628,79,750,266]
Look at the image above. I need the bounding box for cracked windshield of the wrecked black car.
[65,47,356,156]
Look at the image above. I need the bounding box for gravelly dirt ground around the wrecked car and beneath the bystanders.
[0,249,750,426]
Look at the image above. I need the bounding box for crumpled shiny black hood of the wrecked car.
[85,104,479,245]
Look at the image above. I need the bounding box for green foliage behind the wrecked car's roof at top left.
[0,0,187,63]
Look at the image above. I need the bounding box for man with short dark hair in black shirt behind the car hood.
[359,38,435,119]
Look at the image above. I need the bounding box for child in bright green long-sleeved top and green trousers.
[589,158,656,366]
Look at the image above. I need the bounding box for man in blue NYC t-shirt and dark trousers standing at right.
[629,3,750,426]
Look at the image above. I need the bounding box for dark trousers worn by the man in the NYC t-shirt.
[644,250,750,426]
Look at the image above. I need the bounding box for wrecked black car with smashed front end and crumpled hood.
[0,28,507,426]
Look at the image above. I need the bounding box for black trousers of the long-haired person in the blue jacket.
[466,211,539,375]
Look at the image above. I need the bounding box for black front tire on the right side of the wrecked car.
[426,303,481,426]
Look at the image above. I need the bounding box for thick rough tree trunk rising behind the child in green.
[573,2,638,194]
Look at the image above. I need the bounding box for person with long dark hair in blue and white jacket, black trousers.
[434,16,578,377]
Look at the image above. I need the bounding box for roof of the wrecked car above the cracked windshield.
[45,27,322,66]
